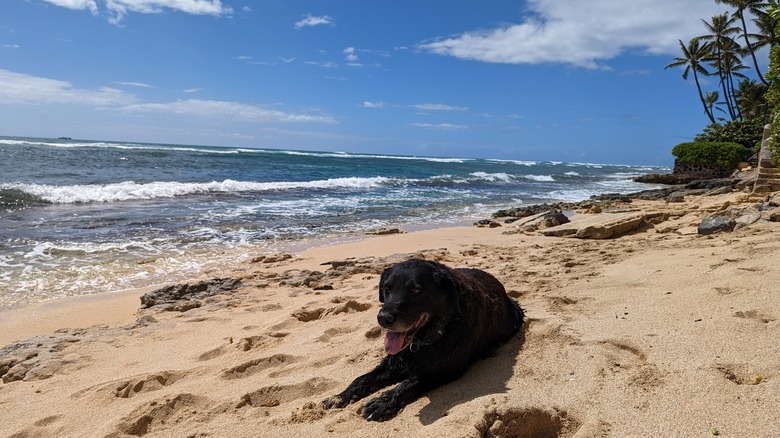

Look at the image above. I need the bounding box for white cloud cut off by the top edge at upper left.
[44,0,233,24]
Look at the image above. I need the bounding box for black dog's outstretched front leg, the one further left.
[322,356,408,409]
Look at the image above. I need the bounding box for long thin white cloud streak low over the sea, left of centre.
[123,99,336,124]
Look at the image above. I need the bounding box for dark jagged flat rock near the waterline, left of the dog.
[141,278,241,312]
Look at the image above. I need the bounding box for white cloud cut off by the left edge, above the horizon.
[0,70,136,106]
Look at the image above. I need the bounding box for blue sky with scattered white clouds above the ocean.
[0,0,766,165]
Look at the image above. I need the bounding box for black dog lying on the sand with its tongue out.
[323,260,524,421]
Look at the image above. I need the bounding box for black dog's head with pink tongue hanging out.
[377,260,460,354]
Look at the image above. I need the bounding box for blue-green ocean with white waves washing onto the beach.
[0,137,668,309]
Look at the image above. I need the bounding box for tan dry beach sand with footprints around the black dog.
[0,195,780,438]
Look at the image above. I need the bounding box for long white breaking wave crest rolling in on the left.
[0,177,391,204]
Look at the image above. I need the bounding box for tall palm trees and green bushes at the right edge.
[666,0,780,165]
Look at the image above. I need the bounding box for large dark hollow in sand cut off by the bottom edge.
[474,408,581,438]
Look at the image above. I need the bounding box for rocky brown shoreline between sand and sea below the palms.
[484,173,780,239]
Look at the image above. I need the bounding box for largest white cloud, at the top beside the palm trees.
[420,0,728,69]
